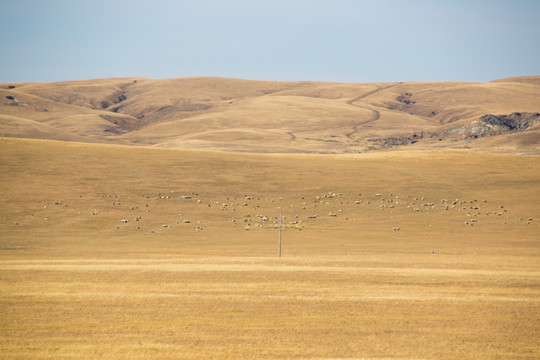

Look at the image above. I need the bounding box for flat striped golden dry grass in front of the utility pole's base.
[1,255,539,359]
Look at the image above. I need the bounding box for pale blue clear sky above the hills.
[0,0,540,83]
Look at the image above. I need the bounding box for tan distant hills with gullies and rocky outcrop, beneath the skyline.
[0,76,540,153]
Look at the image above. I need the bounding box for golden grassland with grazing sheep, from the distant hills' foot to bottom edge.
[0,139,540,359]
